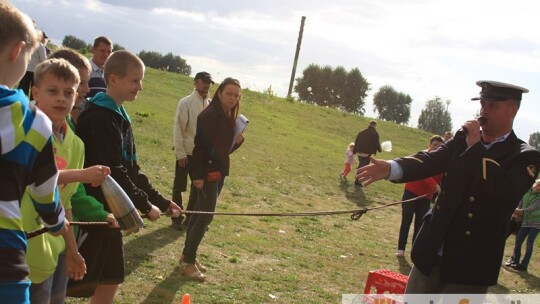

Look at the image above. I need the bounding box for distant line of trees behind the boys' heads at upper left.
[62,35,191,76]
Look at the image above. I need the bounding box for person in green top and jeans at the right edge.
[505,179,540,271]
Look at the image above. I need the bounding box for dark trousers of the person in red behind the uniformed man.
[398,190,430,250]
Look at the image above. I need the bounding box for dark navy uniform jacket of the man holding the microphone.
[396,131,540,286]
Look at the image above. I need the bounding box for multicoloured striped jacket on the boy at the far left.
[0,86,64,282]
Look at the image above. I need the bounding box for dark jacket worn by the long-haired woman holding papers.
[193,101,243,180]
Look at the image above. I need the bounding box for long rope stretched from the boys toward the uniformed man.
[26,193,432,239]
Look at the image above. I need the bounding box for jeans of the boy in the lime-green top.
[30,253,68,304]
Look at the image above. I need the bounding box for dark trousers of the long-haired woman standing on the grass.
[182,176,225,264]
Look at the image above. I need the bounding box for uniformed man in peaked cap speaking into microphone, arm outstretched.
[357,80,540,294]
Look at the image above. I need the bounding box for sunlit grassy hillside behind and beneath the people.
[68,69,540,303]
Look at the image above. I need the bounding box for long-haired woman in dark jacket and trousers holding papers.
[180,78,244,281]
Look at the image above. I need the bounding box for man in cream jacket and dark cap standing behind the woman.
[171,72,214,230]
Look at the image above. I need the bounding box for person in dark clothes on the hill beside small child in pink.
[354,120,382,186]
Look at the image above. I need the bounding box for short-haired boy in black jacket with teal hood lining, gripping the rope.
[68,51,181,303]
